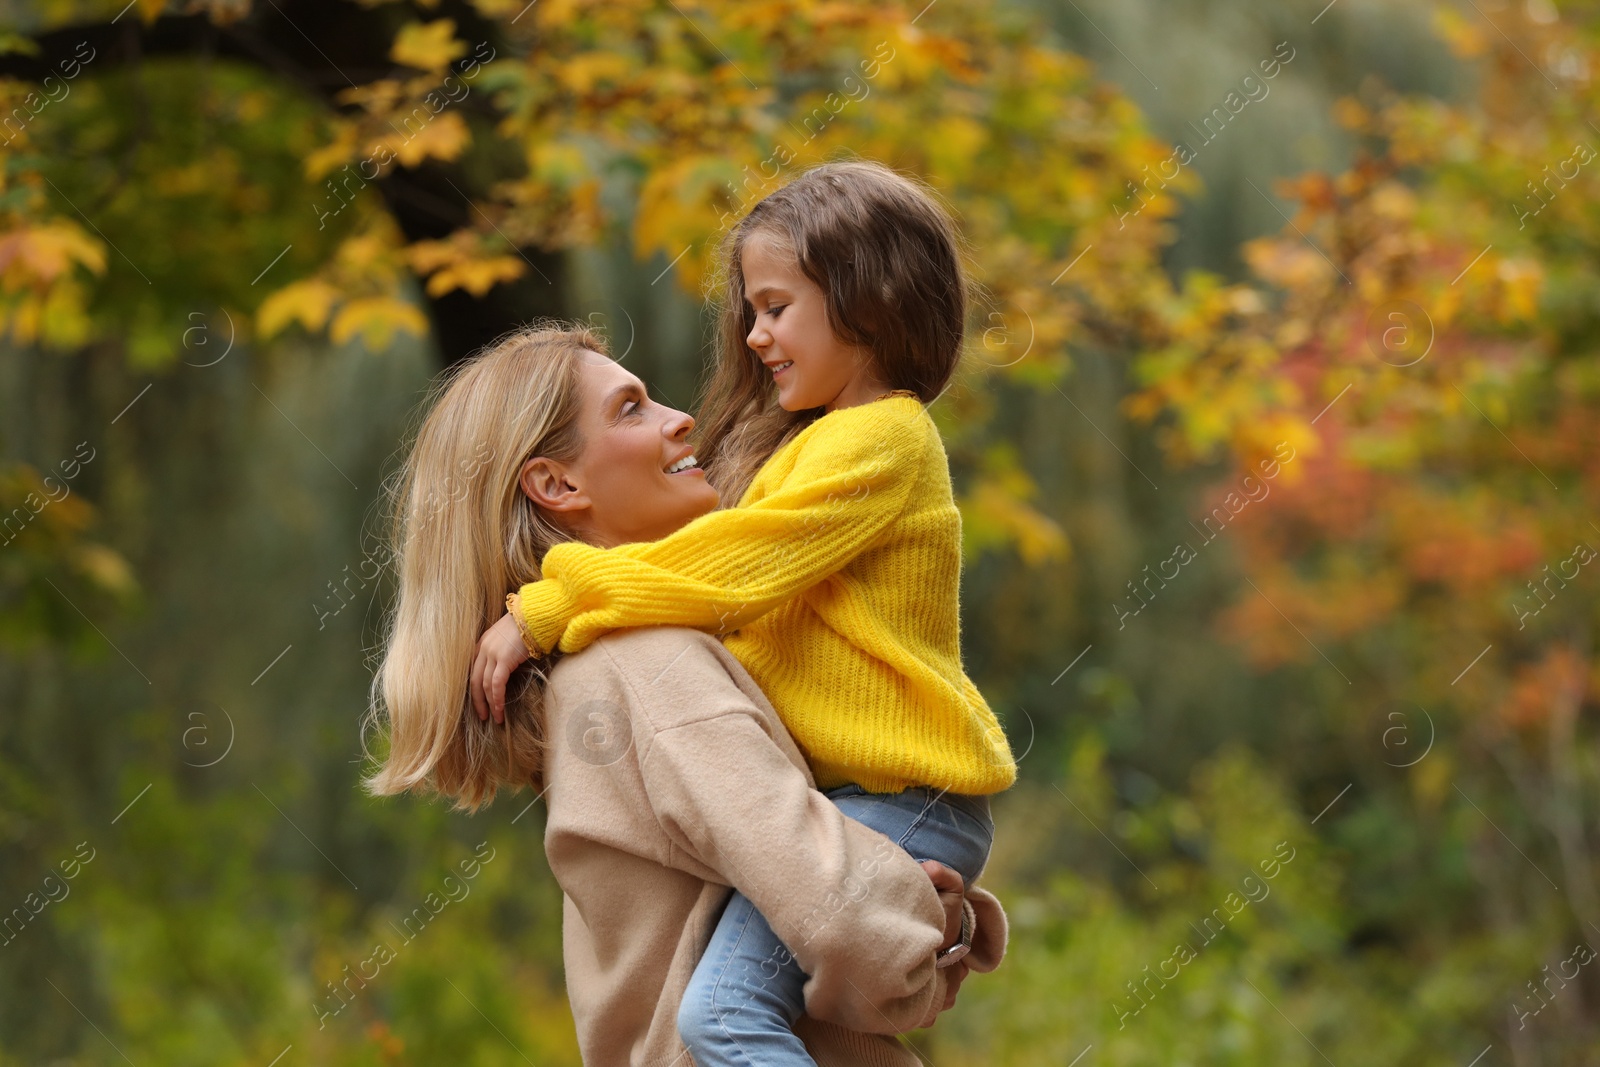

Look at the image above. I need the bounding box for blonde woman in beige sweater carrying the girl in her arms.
[368,328,1005,1065]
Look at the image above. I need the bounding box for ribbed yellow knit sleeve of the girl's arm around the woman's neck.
[520,403,928,653]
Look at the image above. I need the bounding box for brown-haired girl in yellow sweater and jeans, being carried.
[472,162,1016,1067]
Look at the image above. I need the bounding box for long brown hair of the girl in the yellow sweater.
[696,160,968,506]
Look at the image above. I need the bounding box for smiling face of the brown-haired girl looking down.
[739,232,888,411]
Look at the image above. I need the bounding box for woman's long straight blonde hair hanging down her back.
[362,322,608,811]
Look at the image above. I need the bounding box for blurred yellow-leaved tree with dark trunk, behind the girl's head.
[0,0,1216,560]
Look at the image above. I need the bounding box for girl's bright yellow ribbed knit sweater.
[518,395,1016,793]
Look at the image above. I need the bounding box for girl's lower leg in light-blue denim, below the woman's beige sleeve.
[678,893,816,1067]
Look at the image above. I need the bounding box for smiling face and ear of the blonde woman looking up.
[520,352,717,547]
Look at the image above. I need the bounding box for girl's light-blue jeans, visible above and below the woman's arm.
[678,785,995,1067]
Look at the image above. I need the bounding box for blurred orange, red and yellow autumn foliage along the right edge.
[1128,5,1600,1062]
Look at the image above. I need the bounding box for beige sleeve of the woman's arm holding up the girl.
[611,639,949,1033]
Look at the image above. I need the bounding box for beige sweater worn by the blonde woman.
[544,627,1006,1067]
